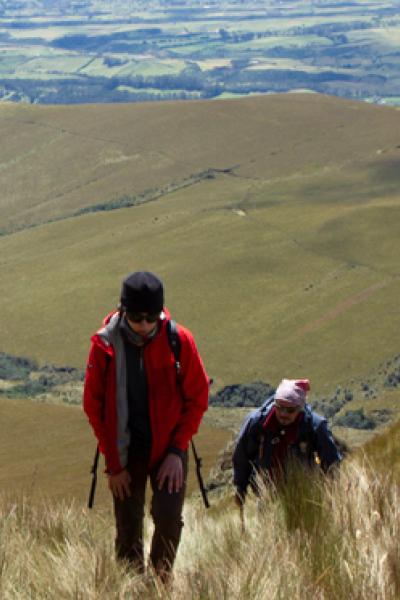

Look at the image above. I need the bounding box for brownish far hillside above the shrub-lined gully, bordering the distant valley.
[0,95,398,227]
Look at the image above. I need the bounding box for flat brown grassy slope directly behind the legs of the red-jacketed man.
[0,398,232,507]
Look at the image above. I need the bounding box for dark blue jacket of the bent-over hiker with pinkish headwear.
[233,396,342,497]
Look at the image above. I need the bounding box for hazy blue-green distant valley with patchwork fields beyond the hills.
[0,0,400,106]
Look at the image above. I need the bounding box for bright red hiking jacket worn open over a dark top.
[83,311,209,474]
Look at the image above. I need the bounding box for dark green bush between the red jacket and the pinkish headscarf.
[210,381,275,408]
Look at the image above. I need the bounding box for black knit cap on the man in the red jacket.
[121,271,164,314]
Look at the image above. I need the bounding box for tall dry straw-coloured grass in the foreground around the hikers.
[0,459,400,600]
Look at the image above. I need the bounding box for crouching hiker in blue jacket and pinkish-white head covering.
[233,379,342,505]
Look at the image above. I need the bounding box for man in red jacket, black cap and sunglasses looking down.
[83,271,209,580]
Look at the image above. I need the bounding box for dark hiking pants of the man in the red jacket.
[114,454,187,576]
